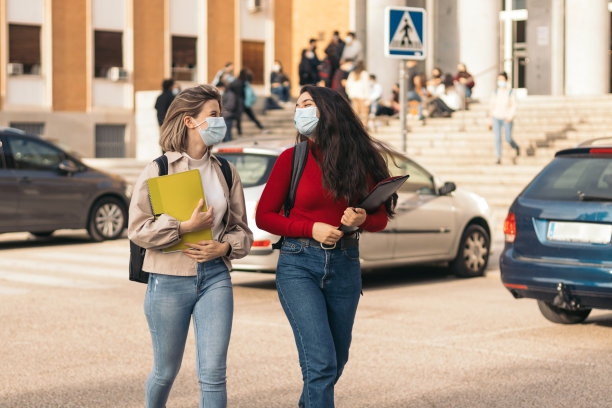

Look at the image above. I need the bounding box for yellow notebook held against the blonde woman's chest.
[148,169,212,252]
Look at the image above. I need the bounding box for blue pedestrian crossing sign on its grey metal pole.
[385,6,426,153]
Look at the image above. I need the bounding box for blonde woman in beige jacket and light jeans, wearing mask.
[128,85,253,408]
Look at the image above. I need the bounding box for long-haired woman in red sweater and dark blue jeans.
[256,86,397,408]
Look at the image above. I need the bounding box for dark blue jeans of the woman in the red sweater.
[276,238,361,408]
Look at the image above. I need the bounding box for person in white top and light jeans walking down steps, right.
[489,72,520,164]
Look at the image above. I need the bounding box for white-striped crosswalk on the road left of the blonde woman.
[0,234,129,297]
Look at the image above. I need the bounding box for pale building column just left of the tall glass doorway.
[456,0,500,100]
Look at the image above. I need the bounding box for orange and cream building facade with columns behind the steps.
[0,0,612,159]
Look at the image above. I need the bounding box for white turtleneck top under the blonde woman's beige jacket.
[183,150,227,241]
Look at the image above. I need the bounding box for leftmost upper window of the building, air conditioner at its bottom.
[8,24,41,75]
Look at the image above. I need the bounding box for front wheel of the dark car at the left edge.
[87,197,127,241]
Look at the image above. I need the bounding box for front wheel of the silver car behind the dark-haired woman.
[450,224,490,278]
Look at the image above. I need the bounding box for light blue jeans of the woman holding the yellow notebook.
[144,258,234,408]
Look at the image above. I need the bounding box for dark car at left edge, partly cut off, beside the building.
[0,128,131,241]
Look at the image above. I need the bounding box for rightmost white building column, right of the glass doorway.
[565,0,610,95]
